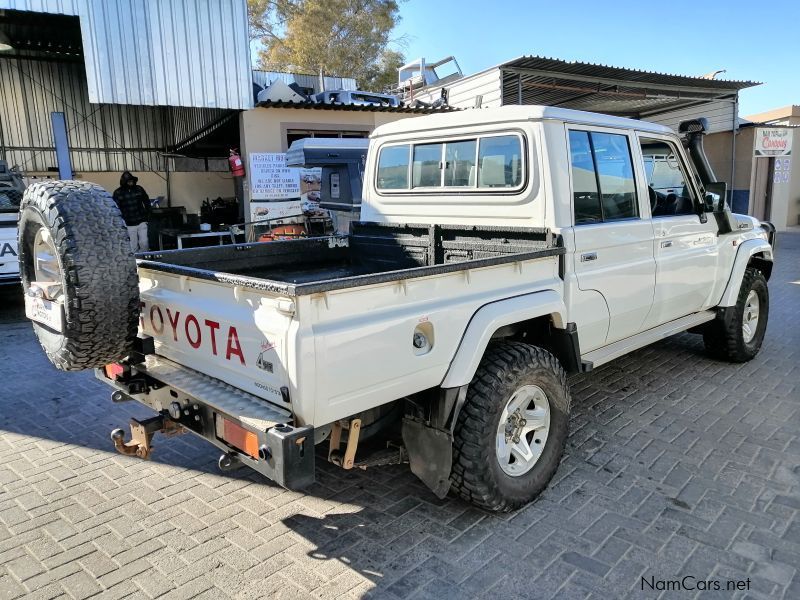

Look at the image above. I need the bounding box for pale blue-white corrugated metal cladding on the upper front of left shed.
[0,0,253,109]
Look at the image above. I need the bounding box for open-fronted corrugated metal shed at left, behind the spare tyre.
[0,0,252,216]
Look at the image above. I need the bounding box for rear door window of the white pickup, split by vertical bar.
[569,130,639,225]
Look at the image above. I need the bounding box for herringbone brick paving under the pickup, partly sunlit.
[0,234,800,600]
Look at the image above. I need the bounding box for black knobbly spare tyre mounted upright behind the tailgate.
[19,181,139,371]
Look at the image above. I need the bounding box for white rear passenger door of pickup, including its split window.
[568,126,655,352]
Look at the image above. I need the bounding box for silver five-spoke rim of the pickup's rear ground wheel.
[495,385,550,477]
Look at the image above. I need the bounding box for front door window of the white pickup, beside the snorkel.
[640,138,696,217]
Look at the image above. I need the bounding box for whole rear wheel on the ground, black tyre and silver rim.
[450,342,570,512]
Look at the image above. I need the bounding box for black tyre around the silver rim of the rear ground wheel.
[450,342,571,512]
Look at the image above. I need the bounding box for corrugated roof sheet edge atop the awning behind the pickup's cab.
[498,56,761,91]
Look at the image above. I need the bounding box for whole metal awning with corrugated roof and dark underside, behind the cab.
[498,56,760,119]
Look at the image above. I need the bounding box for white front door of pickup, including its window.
[638,134,720,329]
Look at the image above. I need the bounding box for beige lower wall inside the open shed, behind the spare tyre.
[24,171,235,213]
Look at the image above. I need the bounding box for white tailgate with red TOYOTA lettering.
[139,268,293,408]
